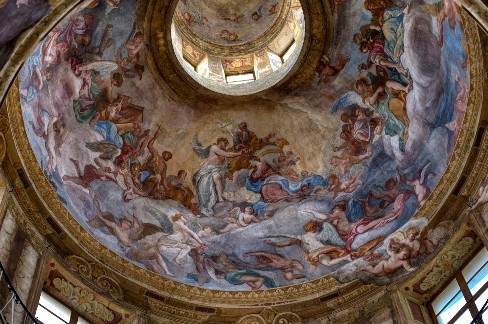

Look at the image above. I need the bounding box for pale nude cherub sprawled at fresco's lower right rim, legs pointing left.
[359,239,417,277]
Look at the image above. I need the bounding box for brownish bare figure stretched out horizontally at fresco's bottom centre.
[241,251,305,281]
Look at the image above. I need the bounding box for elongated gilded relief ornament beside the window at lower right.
[420,237,474,290]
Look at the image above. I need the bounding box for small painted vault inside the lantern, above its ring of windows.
[177,0,283,45]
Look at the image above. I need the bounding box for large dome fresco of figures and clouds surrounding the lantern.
[19,0,470,290]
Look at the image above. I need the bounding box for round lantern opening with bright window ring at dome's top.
[171,0,305,96]
